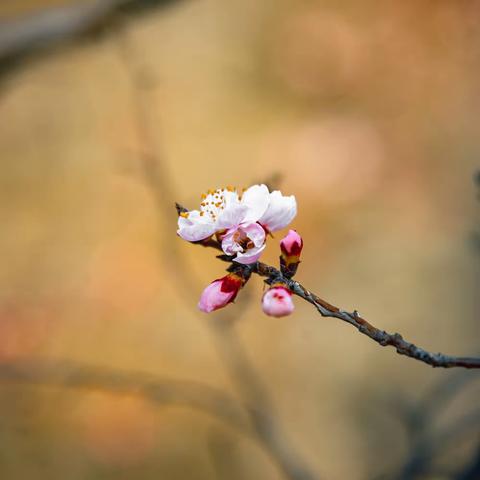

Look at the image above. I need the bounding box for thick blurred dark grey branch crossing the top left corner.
[0,0,186,79]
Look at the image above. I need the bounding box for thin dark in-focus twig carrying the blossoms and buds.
[189,235,480,368]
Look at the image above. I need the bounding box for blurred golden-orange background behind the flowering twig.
[0,0,480,480]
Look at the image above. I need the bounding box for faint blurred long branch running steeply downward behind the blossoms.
[118,30,318,480]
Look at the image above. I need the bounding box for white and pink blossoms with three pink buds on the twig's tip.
[177,185,303,317]
